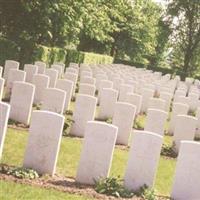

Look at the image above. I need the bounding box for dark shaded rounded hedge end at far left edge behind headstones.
[0,37,19,66]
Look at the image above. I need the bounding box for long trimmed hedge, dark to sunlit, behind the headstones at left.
[0,38,113,66]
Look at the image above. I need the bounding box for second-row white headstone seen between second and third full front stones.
[112,102,136,145]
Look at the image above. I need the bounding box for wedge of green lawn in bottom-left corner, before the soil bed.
[0,181,90,200]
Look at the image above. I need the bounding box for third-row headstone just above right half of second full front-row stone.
[98,88,118,119]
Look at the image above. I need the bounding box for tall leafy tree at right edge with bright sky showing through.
[168,0,200,75]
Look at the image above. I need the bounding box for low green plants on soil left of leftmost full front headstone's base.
[0,165,39,179]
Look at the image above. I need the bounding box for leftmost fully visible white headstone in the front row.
[23,111,65,176]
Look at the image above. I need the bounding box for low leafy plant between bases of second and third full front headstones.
[95,177,134,198]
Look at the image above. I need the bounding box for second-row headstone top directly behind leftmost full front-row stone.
[41,88,66,114]
